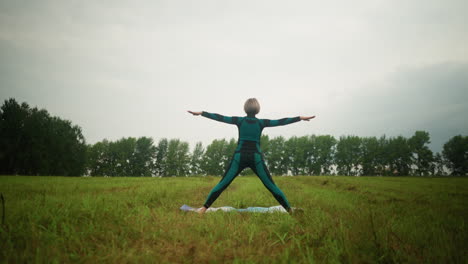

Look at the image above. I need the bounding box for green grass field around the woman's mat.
[0,176,468,263]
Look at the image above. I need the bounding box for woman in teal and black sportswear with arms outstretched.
[188,98,315,214]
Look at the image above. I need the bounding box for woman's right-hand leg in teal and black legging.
[251,153,291,212]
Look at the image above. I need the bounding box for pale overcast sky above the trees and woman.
[0,0,468,151]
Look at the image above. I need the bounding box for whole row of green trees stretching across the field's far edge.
[0,99,468,177]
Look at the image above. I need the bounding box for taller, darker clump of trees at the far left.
[0,99,87,176]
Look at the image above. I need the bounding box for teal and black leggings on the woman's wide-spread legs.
[204,152,291,212]
